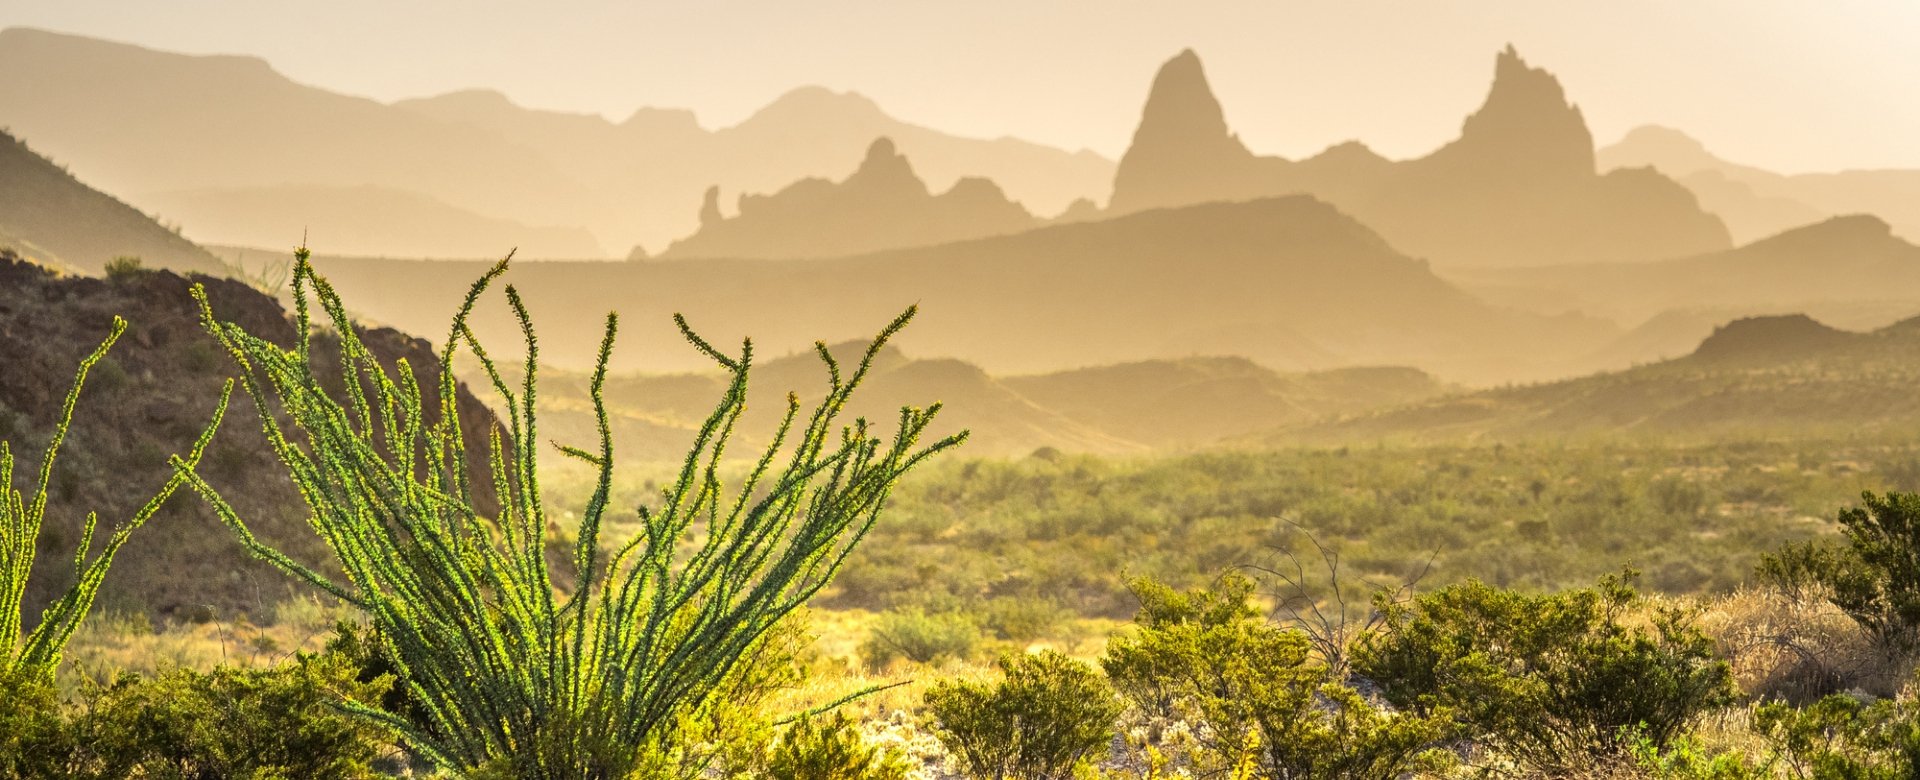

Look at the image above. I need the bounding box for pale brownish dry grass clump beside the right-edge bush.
[1701,588,1914,705]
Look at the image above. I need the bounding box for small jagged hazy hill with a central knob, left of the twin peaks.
[660,138,1039,259]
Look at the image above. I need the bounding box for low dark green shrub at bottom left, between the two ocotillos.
[69,655,392,780]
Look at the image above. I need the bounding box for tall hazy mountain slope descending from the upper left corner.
[0,27,595,255]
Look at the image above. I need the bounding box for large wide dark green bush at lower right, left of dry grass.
[1354,573,1734,774]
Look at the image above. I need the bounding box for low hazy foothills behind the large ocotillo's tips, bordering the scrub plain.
[518,342,1448,461]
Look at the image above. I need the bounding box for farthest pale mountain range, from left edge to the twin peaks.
[0,29,1114,257]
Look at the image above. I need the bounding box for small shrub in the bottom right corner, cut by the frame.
[1753,694,1920,780]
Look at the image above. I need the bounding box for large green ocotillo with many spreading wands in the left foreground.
[179,252,960,780]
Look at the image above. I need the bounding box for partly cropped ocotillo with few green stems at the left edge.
[0,317,232,682]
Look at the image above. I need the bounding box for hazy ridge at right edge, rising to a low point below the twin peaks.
[1450,215,1920,367]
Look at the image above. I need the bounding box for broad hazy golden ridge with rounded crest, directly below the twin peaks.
[317,196,1613,380]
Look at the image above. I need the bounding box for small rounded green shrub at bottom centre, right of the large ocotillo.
[927,649,1121,780]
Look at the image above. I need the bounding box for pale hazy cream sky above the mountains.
[11,0,1920,173]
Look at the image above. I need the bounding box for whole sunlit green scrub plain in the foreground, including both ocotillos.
[0,256,1920,780]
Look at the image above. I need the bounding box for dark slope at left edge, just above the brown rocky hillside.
[0,133,227,275]
